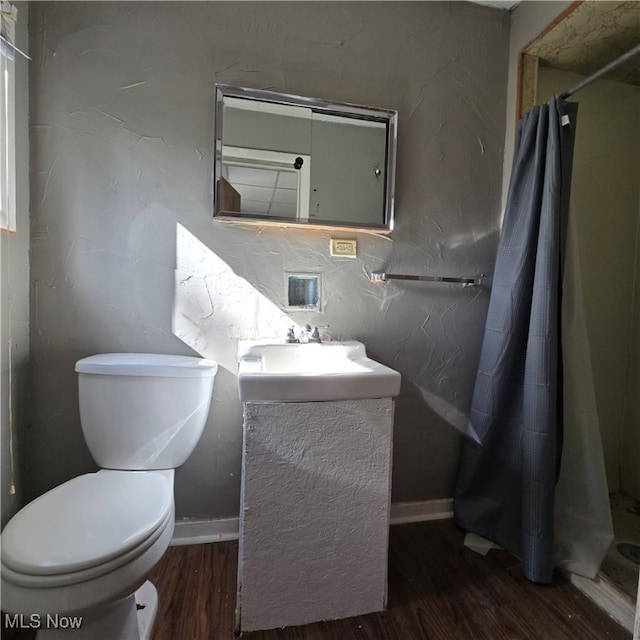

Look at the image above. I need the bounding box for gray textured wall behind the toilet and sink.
[29,2,509,517]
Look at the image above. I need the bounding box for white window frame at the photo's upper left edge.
[0,0,17,232]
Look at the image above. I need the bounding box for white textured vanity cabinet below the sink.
[237,398,394,631]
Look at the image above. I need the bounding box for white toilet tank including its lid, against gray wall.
[76,353,218,471]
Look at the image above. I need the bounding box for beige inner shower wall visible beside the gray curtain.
[538,68,640,495]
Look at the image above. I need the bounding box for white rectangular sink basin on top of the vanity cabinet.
[238,341,400,402]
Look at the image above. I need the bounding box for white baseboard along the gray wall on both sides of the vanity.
[171,498,453,547]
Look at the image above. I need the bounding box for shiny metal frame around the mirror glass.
[213,83,398,234]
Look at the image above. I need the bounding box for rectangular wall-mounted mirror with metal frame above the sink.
[214,84,397,233]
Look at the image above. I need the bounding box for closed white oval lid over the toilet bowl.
[2,470,173,575]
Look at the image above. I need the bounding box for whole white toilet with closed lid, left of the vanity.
[1,353,218,640]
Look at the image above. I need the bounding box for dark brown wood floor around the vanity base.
[152,520,631,640]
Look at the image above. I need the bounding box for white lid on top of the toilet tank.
[76,353,218,378]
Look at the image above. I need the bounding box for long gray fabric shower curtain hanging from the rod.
[454,98,577,583]
